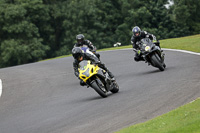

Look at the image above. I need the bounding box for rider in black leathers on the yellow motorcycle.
[72,47,115,86]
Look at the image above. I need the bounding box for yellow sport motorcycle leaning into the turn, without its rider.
[78,60,119,98]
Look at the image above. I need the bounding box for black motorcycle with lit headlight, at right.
[134,38,166,71]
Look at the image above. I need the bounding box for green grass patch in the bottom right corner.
[116,99,200,133]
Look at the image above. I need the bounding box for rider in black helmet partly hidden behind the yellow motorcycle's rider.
[74,34,100,59]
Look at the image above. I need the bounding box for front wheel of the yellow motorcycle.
[91,79,107,98]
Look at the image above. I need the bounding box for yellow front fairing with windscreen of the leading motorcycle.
[78,60,99,82]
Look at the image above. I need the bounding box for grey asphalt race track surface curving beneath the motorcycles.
[0,49,200,133]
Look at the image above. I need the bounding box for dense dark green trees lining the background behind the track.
[0,0,200,68]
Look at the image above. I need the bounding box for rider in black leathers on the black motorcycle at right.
[131,26,163,61]
